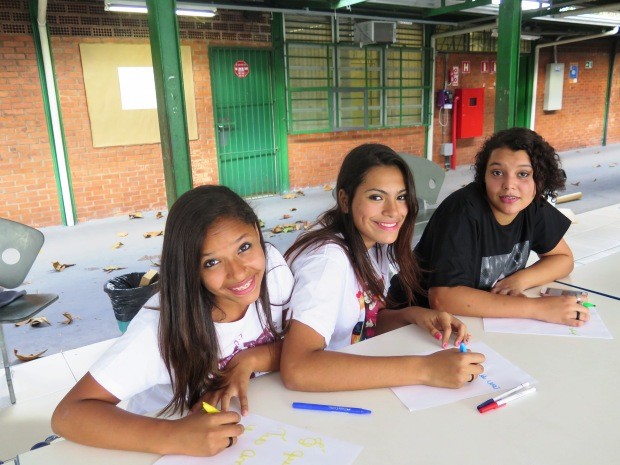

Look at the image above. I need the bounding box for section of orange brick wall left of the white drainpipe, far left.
[0,35,61,226]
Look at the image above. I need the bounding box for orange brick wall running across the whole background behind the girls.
[0,0,620,227]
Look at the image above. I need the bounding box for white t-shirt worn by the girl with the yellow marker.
[90,244,293,414]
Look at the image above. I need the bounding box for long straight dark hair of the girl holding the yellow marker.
[159,186,281,413]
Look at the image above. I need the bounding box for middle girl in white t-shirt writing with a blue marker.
[280,144,484,391]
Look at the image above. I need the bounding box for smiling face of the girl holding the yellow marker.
[200,218,265,322]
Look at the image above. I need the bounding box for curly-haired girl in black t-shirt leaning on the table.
[390,128,589,326]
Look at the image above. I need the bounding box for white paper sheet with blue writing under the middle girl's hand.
[392,342,537,412]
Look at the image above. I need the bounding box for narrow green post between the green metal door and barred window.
[271,13,290,193]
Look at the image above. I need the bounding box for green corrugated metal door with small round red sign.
[209,47,279,196]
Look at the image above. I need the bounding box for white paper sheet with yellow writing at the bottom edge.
[154,414,362,465]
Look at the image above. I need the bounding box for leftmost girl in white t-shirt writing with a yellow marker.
[52,186,293,456]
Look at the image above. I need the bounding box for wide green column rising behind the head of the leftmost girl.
[146,0,193,207]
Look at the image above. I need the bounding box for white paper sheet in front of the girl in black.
[483,308,613,339]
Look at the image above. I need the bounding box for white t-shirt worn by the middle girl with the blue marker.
[289,239,389,350]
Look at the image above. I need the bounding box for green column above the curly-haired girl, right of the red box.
[494,0,521,132]
